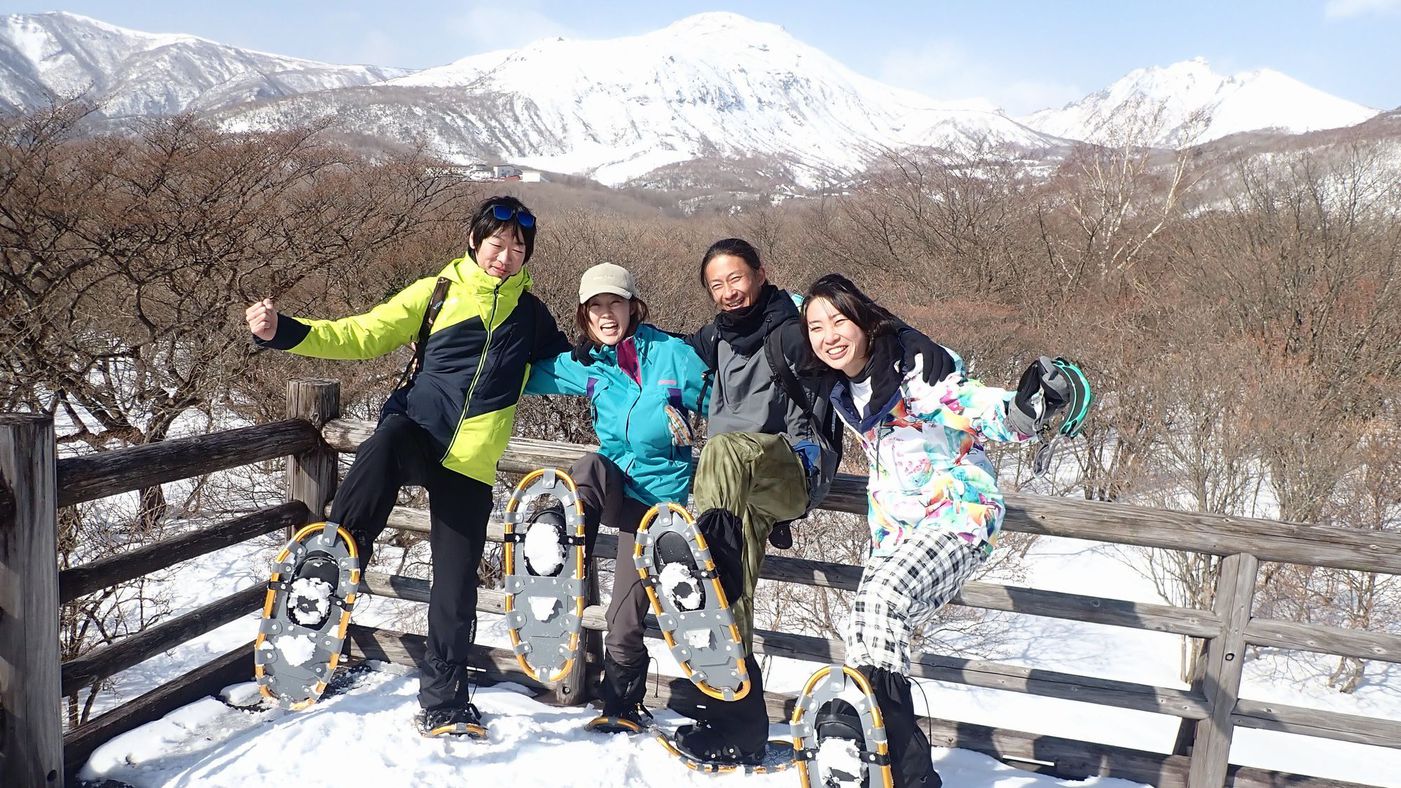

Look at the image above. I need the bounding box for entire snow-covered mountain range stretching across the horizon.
[0,13,1377,191]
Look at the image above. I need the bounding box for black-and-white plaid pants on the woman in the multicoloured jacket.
[846,526,984,667]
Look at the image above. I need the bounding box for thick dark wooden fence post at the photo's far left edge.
[0,414,63,787]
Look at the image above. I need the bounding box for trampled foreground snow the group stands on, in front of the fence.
[83,670,1133,788]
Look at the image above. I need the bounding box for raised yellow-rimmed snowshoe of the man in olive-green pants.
[633,503,751,701]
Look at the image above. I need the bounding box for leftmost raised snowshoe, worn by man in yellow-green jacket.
[254,523,360,709]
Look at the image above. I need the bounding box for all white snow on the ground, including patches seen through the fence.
[84,518,1401,788]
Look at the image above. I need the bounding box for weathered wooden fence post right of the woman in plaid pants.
[1187,552,1259,788]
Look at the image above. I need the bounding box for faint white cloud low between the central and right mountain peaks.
[878,41,1086,116]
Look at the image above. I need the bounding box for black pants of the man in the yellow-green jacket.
[331,414,492,708]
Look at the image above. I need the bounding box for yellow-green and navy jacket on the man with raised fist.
[258,257,569,484]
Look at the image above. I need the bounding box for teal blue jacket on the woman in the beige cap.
[525,322,708,506]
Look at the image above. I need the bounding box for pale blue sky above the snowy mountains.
[10,0,1401,114]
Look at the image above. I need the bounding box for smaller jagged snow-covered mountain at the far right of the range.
[1020,57,1377,147]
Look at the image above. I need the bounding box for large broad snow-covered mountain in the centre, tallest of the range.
[210,13,1063,184]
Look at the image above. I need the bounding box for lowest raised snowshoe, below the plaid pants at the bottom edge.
[790,665,895,788]
